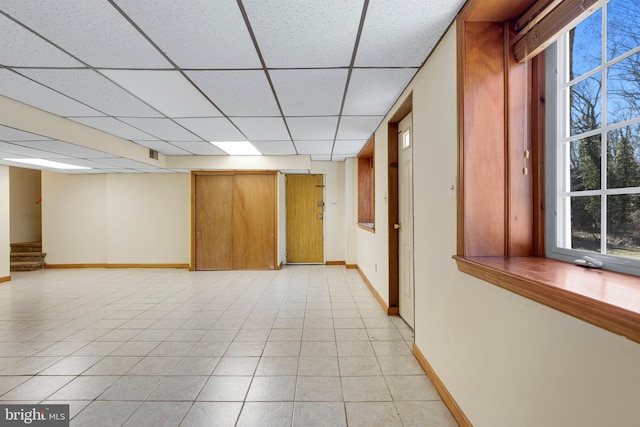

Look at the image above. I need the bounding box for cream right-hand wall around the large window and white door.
[358,26,640,427]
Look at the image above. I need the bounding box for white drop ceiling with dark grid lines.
[0,0,464,173]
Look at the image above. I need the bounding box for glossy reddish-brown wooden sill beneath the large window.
[453,256,640,343]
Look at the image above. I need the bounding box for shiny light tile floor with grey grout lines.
[0,266,456,427]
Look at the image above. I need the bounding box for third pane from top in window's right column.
[607,123,640,188]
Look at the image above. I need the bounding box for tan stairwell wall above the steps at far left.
[9,167,42,243]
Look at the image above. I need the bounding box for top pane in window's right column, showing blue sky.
[607,0,640,60]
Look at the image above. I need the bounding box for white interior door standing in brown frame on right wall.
[398,113,414,328]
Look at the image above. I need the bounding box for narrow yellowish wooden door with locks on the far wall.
[287,175,324,264]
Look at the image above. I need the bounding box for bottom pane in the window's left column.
[571,196,600,252]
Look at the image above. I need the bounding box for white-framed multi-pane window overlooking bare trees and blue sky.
[546,0,640,274]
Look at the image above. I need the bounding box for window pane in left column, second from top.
[569,73,602,135]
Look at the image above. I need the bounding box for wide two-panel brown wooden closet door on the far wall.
[192,172,277,270]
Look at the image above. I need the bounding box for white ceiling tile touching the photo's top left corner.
[1,0,171,68]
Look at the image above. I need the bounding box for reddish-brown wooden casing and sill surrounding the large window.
[454,0,640,342]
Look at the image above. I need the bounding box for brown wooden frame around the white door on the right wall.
[387,92,413,315]
